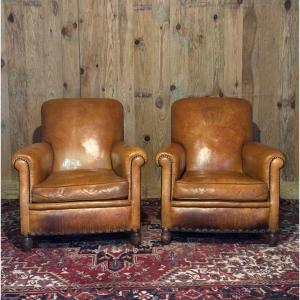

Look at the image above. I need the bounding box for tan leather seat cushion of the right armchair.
[173,171,269,201]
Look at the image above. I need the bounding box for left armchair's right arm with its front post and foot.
[112,142,147,246]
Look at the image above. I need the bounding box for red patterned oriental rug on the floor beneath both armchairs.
[2,200,298,300]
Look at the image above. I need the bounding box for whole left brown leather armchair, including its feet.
[12,99,147,250]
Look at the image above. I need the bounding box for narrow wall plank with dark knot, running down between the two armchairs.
[148,0,171,198]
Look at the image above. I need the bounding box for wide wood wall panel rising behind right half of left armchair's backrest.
[79,0,135,143]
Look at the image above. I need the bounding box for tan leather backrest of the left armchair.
[42,99,123,172]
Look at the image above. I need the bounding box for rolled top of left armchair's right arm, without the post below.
[111,142,147,180]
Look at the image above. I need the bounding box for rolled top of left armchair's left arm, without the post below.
[12,143,53,187]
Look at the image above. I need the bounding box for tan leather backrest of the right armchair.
[172,97,252,172]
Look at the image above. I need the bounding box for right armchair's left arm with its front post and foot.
[156,143,185,244]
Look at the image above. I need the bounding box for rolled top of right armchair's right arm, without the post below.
[242,142,285,188]
